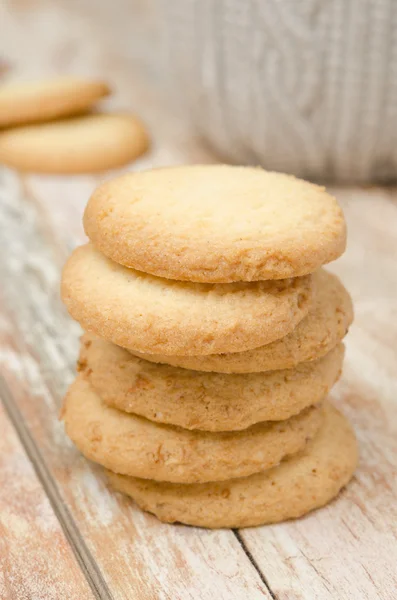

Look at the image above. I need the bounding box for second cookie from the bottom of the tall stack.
[63,376,323,483]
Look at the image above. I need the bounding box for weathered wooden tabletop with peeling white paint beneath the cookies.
[0,0,397,600]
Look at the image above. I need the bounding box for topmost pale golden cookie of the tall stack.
[84,165,346,283]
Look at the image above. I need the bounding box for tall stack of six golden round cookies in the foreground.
[62,165,357,528]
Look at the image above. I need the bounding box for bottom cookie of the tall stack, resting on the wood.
[107,405,358,529]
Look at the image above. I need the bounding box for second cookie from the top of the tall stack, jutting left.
[62,244,311,355]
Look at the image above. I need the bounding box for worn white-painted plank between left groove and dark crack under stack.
[0,171,270,600]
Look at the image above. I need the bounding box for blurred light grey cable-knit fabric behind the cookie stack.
[159,0,397,182]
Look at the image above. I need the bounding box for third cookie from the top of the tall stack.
[131,269,353,373]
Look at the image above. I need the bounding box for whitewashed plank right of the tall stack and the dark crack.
[241,188,397,600]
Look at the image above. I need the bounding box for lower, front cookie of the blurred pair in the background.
[0,113,149,174]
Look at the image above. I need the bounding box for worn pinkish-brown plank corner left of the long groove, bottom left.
[0,396,94,600]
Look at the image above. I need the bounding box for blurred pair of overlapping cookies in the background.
[0,76,149,174]
